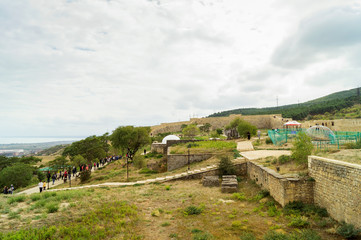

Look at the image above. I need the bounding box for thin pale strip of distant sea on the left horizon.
[0,137,86,144]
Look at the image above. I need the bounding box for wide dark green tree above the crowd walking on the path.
[63,136,109,163]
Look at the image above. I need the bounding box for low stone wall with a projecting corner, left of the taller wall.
[247,161,314,207]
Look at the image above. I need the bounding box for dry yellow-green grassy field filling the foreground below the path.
[0,180,340,240]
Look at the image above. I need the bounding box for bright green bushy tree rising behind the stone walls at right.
[292,132,313,164]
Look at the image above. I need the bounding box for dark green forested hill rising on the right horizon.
[208,88,361,120]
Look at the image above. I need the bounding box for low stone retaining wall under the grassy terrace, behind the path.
[167,153,213,171]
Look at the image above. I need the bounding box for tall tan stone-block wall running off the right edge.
[308,156,361,228]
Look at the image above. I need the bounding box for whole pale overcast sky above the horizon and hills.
[0,0,361,136]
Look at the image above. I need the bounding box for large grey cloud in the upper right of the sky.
[271,7,361,68]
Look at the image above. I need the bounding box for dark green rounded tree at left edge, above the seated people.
[0,163,33,188]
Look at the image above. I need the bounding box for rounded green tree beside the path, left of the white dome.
[110,126,150,160]
